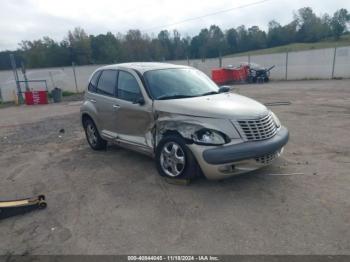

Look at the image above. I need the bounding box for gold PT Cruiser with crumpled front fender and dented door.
[81,63,289,179]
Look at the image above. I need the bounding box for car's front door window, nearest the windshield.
[118,71,141,102]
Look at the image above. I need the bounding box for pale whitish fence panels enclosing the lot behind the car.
[0,46,350,101]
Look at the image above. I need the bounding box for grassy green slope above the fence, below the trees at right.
[225,34,350,57]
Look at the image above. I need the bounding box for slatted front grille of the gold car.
[238,114,277,141]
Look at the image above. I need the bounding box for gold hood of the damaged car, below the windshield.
[154,93,268,119]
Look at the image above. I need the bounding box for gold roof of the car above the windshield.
[100,62,188,74]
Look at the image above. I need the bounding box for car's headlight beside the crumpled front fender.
[192,129,229,145]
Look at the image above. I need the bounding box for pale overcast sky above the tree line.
[0,0,350,51]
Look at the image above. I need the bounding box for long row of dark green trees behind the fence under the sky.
[0,7,350,70]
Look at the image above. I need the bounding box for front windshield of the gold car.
[144,68,219,100]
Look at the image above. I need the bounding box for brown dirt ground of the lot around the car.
[0,80,350,254]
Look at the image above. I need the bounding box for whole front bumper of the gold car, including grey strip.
[189,127,289,179]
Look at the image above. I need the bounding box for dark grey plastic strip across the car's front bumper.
[203,127,289,165]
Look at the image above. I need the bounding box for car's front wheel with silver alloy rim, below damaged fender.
[156,135,199,179]
